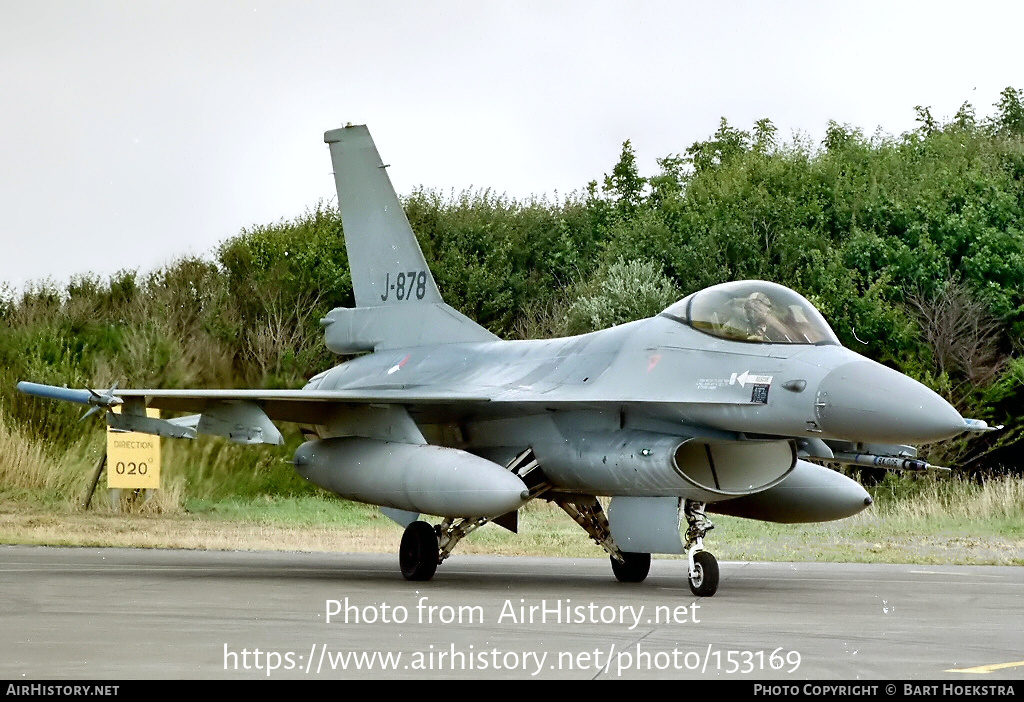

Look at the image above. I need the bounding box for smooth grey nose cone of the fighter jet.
[815,359,967,444]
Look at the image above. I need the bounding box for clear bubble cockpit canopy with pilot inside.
[662,280,839,345]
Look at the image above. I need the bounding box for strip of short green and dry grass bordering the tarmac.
[0,486,1024,565]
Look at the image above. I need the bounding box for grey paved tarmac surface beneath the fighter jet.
[0,546,1024,685]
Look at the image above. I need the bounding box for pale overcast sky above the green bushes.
[0,0,1024,288]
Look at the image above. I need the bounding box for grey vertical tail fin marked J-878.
[324,125,442,307]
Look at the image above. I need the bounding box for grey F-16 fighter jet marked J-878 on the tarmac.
[18,126,988,596]
